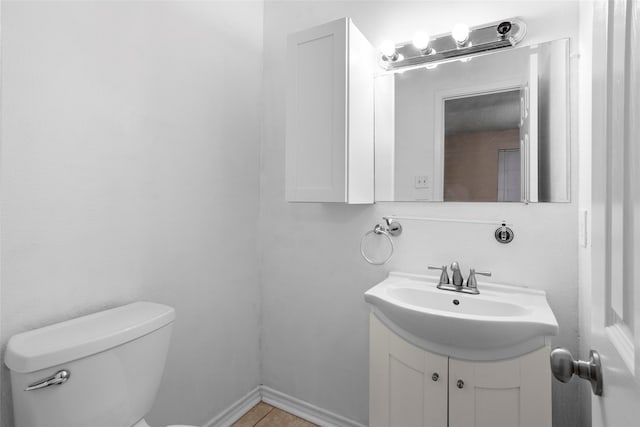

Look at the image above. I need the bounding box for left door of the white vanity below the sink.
[369,314,448,427]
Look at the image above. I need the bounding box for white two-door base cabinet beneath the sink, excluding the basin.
[369,314,551,427]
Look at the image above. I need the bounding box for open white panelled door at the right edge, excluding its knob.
[590,0,640,427]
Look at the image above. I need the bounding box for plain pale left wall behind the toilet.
[0,1,263,427]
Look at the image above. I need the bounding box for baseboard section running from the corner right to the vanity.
[260,386,365,427]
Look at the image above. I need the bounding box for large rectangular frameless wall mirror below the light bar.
[375,39,570,202]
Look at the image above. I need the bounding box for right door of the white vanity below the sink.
[449,347,551,427]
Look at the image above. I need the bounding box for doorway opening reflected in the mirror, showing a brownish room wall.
[443,87,521,202]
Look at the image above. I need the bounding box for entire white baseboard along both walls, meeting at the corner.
[203,385,366,427]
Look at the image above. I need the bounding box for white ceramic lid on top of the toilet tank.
[4,302,176,373]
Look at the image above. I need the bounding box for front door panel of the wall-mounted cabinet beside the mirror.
[286,19,348,202]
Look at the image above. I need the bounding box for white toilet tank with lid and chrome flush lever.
[5,302,198,427]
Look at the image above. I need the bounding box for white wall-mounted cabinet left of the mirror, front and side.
[286,18,375,203]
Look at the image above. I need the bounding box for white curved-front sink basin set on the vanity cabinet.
[364,273,558,360]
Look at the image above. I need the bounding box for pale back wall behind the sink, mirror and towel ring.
[260,1,583,427]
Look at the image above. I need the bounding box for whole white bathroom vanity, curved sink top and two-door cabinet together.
[365,273,558,427]
